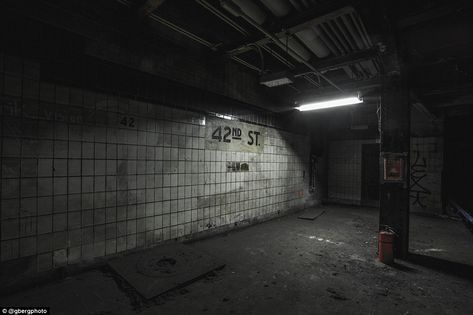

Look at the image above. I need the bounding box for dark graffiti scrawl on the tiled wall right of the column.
[409,151,431,208]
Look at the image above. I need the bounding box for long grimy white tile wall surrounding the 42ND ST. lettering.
[0,56,308,271]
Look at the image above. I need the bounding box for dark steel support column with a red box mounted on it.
[379,59,410,257]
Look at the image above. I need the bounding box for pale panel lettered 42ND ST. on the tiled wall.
[205,118,266,153]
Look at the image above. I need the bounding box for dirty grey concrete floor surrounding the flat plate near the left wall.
[0,206,473,314]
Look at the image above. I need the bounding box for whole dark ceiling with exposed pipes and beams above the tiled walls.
[2,0,473,113]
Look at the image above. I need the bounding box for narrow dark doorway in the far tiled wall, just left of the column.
[361,143,379,206]
